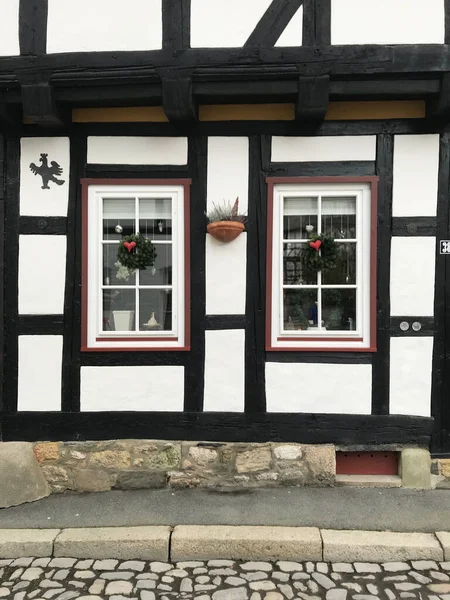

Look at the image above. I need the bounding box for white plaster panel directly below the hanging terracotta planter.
[206,233,247,315]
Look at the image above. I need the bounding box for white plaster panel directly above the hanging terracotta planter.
[207,137,249,213]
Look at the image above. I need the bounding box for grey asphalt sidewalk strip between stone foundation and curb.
[0,487,450,532]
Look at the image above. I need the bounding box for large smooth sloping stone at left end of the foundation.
[0,442,50,508]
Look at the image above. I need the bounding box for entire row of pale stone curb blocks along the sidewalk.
[0,526,450,572]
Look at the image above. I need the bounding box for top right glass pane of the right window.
[322,197,356,239]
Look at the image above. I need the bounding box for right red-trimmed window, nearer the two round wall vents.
[266,177,377,351]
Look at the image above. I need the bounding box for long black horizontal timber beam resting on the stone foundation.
[0,412,433,447]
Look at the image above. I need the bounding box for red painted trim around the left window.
[80,179,192,352]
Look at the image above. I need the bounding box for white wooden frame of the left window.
[85,183,188,350]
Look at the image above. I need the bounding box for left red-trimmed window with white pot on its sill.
[83,180,189,350]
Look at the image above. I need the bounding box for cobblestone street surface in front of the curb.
[0,558,450,600]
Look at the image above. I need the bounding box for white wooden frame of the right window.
[267,181,375,351]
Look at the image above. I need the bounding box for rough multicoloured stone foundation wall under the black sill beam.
[34,440,336,492]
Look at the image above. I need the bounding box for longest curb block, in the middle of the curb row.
[171,525,322,561]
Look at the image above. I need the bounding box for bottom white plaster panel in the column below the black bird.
[18,335,63,411]
